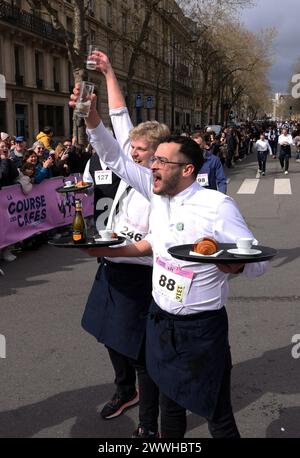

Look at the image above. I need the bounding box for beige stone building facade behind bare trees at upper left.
[0,0,194,143]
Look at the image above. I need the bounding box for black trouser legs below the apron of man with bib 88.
[160,352,240,438]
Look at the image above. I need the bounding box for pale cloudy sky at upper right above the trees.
[241,0,300,93]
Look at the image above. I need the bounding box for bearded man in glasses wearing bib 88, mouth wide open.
[70,70,267,438]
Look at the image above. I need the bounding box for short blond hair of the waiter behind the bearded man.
[129,121,170,150]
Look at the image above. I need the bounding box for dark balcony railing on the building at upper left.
[0,0,73,42]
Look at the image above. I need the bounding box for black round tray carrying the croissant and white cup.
[168,243,277,264]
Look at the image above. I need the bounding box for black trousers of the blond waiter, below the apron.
[107,341,159,432]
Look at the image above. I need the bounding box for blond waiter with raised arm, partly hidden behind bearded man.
[82,58,170,438]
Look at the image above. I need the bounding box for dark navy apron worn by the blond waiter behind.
[81,259,152,359]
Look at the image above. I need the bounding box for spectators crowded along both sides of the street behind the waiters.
[0,121,300,273]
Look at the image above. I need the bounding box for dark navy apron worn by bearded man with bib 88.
[146,302,230,419]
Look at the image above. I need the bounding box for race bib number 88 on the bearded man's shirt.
[153,258,194,304]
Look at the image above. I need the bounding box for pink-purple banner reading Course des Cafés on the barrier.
[0,177,94,248]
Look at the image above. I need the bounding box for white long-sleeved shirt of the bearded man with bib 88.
[89,123,268,315]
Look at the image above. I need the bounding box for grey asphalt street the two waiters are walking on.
[0,155,300,438]
